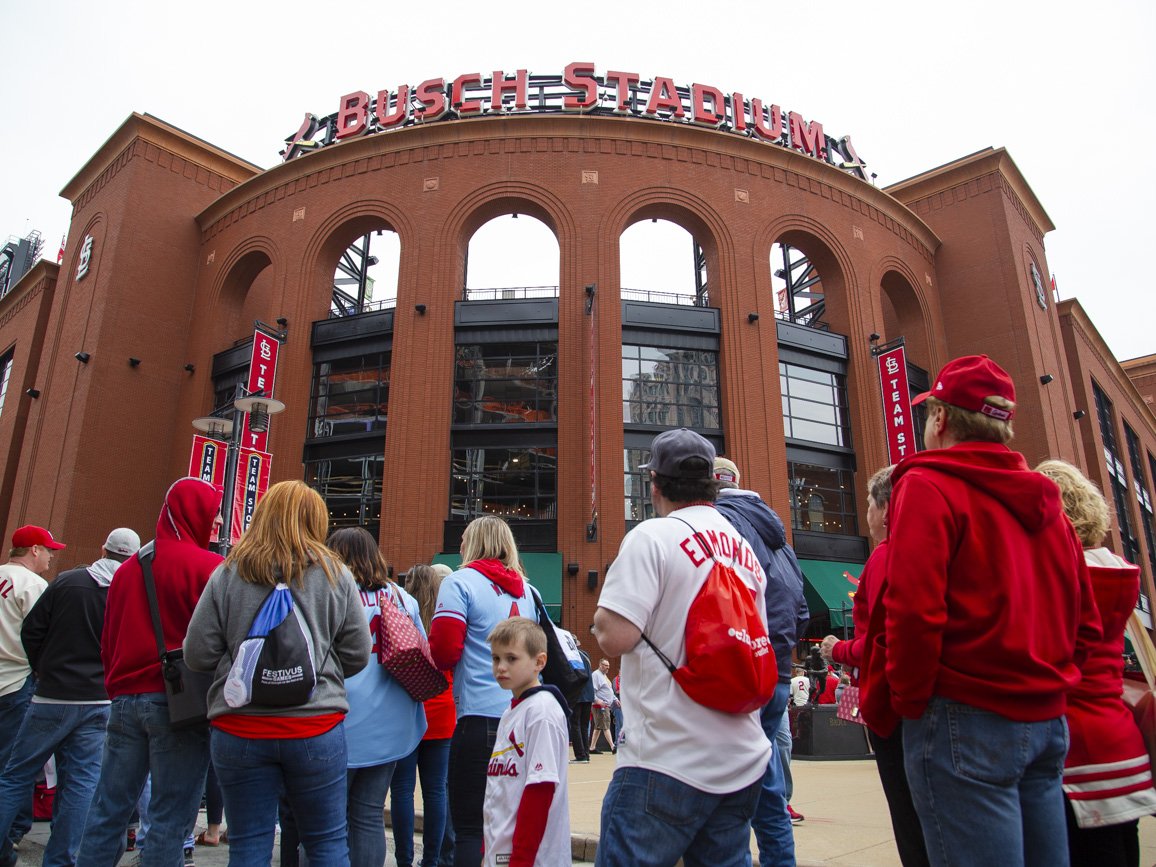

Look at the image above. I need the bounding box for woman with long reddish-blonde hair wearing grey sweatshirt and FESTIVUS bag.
[185,482,370,867]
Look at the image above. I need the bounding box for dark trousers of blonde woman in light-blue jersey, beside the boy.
[450,717,501,867]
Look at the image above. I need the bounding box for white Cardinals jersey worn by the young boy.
[482,690,570,867]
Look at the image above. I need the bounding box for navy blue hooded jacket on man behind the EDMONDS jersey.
[714,488,810,683]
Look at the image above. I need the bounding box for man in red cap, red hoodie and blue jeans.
[864,355,1101,865]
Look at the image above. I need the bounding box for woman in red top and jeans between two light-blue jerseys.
[390,564,457,867]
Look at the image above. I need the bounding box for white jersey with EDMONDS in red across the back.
[598,506,771,794]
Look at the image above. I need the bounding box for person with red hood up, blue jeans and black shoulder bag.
[76,479,225,867]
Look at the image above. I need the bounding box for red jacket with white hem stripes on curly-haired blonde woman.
[1064,548,1156,828]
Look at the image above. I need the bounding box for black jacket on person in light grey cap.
[20,566,109,702]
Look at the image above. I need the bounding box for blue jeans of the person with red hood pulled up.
[76,692,209,867]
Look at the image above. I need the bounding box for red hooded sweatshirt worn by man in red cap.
[864,443,1102,734]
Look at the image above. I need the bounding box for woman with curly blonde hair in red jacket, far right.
[1036,460,1156,867]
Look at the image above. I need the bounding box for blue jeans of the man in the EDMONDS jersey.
[594,768,763,867]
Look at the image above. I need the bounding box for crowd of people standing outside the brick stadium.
[0,356,1156,867]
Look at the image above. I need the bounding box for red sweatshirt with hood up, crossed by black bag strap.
[101,479,222,698]
